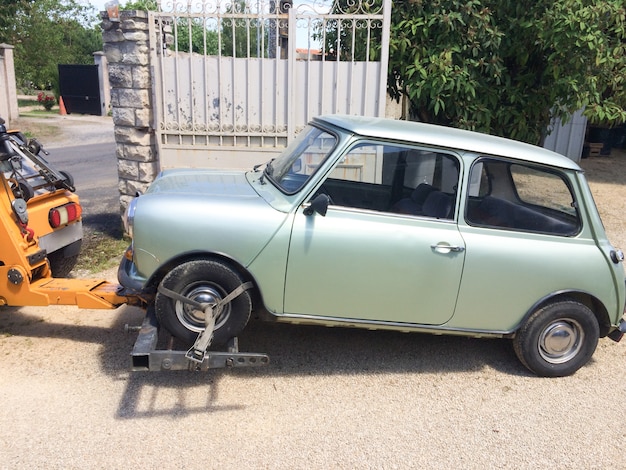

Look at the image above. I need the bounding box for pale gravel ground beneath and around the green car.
[0,119,626,469]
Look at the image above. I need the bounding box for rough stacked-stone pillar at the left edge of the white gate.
[101,10,159,213]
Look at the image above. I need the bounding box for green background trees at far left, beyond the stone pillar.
[0,0,102,89]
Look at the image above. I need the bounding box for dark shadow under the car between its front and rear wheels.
[232,320,528,375]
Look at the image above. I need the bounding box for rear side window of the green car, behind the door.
[466,159,581,236]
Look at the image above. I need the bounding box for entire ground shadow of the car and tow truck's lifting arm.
[0,306,532,419]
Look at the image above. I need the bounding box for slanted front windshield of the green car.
[265,125,337,194]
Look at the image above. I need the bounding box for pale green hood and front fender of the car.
[133,169,288,278]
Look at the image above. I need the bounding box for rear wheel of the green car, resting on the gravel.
[513,300,600,377]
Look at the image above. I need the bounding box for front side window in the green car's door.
[319,142,459,219]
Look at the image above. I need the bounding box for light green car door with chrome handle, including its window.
[284,143,465,325]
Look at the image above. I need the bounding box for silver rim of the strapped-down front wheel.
[175,283,230,333]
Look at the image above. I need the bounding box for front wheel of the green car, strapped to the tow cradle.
[155,260,252,346]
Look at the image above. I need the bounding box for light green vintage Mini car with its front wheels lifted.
[118,116,626,376]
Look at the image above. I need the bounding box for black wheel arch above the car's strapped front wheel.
[146,251,265,312]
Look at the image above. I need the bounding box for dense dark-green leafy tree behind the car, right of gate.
[390,0,626,143]
